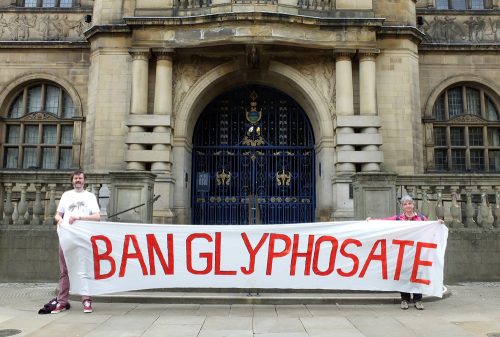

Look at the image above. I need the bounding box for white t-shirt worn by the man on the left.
[57,190,100,223]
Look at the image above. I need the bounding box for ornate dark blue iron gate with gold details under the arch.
[192,85,315,224]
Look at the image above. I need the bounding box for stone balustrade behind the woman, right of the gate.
[396,174,500,230]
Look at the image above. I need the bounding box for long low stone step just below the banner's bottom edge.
[81,287,451,305]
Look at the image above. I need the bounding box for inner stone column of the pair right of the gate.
[335,51,356,173]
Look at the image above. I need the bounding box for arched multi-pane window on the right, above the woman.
[432,84,500,172]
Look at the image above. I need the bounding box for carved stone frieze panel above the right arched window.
[420,16,500,43]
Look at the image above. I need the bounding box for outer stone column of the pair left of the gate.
[127,49,149,171]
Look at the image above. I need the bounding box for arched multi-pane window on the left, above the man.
[1,82,81,170]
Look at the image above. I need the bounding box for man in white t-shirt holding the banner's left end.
[51,170,101,314]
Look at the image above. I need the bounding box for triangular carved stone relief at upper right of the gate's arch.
[278,57,335,112]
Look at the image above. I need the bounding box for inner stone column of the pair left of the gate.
[151,49,174,223]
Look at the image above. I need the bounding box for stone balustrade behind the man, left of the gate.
[0,171,155,228]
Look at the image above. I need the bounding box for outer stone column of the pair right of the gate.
[359,52,380,172]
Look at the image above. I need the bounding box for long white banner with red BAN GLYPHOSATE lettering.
[58,220,448,297]
